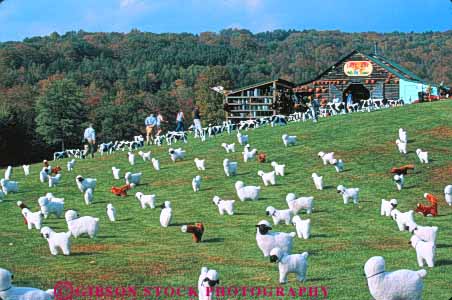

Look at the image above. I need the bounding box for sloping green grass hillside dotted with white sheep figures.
[0,102,452,299]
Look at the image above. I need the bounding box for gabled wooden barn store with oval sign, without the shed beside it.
[293,50,438,103]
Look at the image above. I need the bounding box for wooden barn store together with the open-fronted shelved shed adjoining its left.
[224,50,438,122]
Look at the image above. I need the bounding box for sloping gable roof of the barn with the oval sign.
[299,50,431,85]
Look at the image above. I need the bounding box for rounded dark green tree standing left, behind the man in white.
[36,79,86,150]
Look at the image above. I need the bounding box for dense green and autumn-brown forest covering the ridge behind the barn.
[0,29,452,165]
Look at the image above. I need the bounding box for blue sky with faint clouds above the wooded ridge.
[0,0,452,42]
